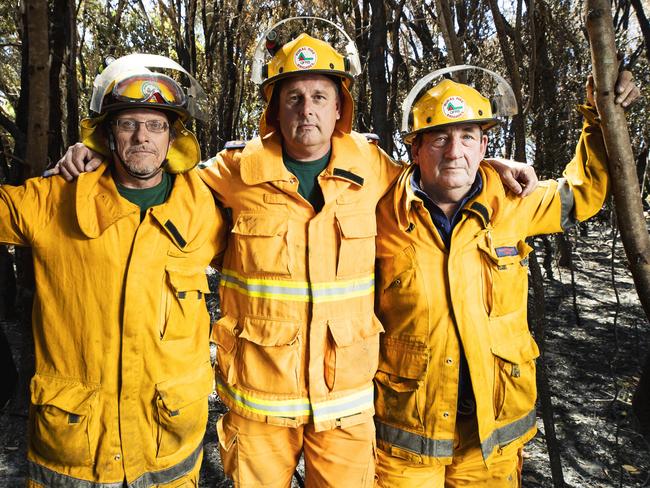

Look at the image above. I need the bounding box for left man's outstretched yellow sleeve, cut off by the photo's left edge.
[0,177,58,246]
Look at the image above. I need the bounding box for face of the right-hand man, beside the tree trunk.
[412,124,487,198]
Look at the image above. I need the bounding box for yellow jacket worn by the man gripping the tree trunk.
[375,106,608,465]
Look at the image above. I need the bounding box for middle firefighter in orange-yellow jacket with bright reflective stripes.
[201,21,398,488]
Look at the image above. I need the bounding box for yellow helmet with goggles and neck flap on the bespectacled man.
[80,54,205,173]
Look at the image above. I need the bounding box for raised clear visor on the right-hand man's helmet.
[401,64,518,134]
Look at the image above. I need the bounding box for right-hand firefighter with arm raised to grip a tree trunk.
[375,67,638,488]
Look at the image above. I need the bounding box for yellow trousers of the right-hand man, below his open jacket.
[376,415,522,488]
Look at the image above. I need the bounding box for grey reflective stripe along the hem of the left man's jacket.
[28,444,203,488]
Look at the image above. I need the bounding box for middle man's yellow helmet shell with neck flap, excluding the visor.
[260,33,354,137]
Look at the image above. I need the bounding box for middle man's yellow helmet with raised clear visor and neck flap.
[253,17,361,137]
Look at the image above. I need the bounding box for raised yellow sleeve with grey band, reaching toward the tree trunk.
[518,105,609,236]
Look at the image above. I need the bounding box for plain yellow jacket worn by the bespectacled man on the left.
[0,165,223,487]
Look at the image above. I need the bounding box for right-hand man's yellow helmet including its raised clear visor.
[402,65,517,144]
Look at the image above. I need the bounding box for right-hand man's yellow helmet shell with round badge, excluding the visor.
[404,79,498,144]
